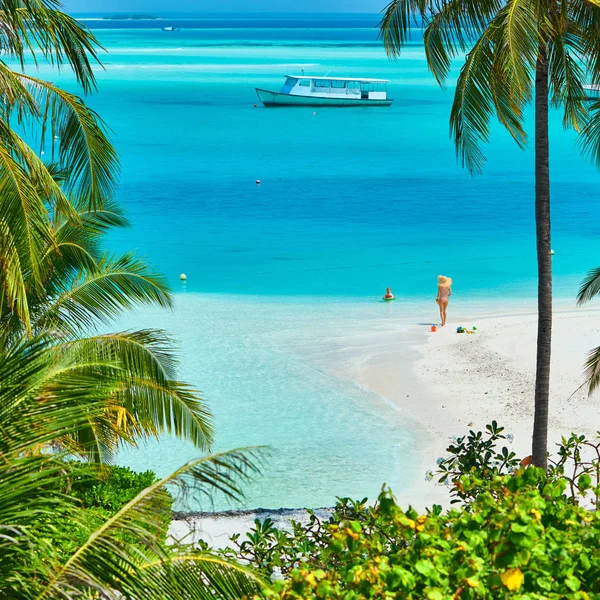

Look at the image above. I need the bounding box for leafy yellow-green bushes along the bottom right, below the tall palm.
[230,423,600,600]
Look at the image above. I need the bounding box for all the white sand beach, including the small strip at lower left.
[172,305,600,545]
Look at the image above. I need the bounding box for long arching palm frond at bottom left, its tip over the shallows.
[35,448,260,600]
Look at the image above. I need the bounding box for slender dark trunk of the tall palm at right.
[532,46,552,469]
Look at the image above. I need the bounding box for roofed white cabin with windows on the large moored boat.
[280,75,388,100]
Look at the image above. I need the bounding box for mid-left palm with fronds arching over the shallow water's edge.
[0,192,213,461]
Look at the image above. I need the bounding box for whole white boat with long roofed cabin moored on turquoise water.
[256,75,393,106]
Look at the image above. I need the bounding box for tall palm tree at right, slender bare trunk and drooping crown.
[381,0,600,468]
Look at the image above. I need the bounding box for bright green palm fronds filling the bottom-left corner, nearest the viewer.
[0,337,261,600]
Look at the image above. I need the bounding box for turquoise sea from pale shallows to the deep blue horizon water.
[42,15,600,508]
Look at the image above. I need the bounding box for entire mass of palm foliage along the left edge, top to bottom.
[0,0,258,599]
